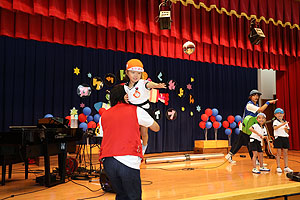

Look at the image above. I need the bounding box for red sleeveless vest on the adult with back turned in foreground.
[99,103,143,159]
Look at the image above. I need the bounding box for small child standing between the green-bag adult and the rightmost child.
[249,113,270,174]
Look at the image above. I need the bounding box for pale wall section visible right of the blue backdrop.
[257,69,276,99]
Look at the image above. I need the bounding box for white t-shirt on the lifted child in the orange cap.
[124,79,150,109]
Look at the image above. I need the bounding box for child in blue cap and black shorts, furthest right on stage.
[273,108,293,173]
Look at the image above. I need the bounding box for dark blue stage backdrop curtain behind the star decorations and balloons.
[0,37,257,152]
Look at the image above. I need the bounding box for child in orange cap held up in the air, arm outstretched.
[124,59,166,153]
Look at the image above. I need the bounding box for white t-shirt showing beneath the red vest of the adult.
[99,107,154,170]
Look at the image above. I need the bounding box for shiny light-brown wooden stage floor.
[0,151,300,200]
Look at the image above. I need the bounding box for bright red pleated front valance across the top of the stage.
[0,0,300,57]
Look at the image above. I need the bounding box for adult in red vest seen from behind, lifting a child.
[99,85,160,199]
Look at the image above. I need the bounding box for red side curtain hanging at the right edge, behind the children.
[276,58,300,150]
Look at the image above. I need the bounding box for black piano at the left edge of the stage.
[0,119,83,187]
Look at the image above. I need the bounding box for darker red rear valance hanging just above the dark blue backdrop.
[0,7,292,70]
